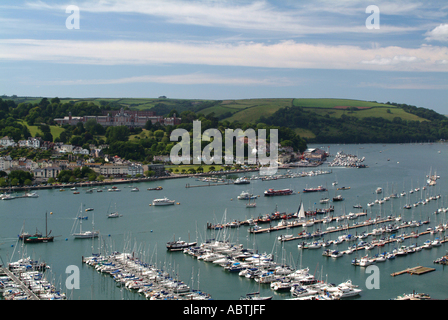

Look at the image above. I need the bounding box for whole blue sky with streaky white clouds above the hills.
[0,0,448,114]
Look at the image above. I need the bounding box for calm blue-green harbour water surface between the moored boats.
[0,144,448,300]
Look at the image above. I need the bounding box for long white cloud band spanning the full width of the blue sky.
[0,39,448,72]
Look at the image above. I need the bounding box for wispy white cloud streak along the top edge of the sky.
[22,0,422,36]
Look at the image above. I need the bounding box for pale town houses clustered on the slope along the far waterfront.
[0,131,328,187]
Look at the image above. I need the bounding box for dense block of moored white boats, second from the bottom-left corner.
[83,252,211,300]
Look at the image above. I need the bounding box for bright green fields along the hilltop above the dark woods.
[7,97,425,128]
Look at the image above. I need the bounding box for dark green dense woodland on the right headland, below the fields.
[258,106,448,143]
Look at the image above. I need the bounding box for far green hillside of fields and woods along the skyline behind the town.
[3,97,448,143]
